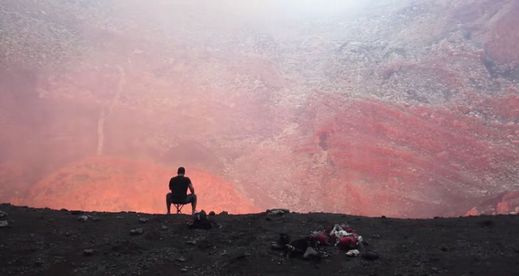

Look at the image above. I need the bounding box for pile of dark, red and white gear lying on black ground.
[272,224,373,259]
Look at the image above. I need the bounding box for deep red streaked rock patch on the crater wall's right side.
[304,98,519,216]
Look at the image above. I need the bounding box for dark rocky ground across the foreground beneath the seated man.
[0,204,519,275]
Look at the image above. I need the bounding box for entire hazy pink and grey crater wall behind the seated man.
[0,0,519,217]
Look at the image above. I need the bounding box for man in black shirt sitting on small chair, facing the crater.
[166,167,196,215]
